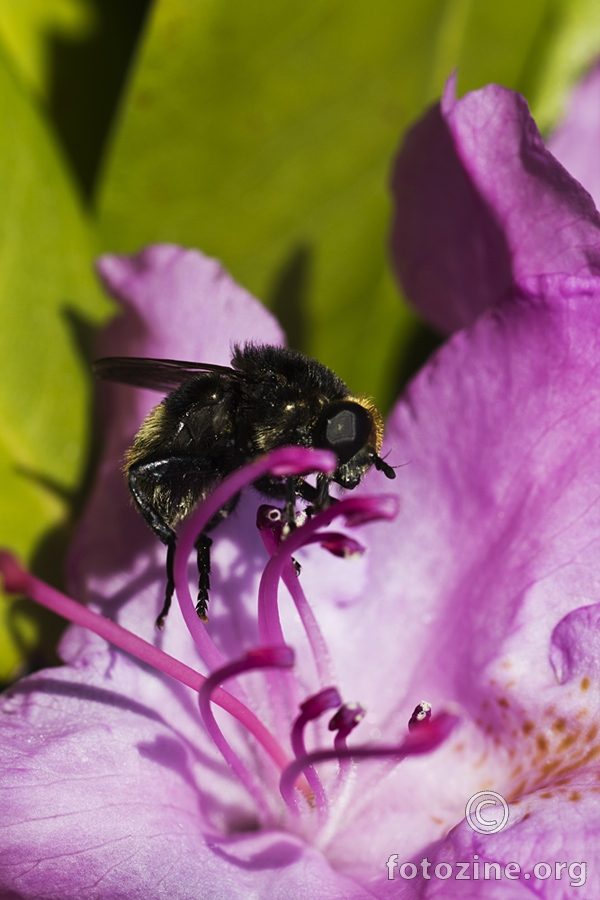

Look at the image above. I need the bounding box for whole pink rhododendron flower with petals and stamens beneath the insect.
[0,70,600,900]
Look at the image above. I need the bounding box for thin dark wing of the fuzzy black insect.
[94,356,240,392]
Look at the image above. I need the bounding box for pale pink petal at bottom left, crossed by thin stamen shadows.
[0,653,365,900]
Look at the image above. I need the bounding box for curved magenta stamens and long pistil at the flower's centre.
[0,447,456,825]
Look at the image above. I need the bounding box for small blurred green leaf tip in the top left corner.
[0,0,96,96]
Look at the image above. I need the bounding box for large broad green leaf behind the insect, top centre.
[98,0,576,407]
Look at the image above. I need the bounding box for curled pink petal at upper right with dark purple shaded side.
[392,79,600,331]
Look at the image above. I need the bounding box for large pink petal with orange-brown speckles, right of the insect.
[302,278,600,871]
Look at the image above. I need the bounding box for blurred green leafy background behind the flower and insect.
[0,0,600,681]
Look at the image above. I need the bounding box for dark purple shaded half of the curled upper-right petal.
[391,104,513,332]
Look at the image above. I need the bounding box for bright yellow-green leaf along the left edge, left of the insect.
[0,44,110,678]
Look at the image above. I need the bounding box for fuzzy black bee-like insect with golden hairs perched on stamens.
[94,343,395,628]
